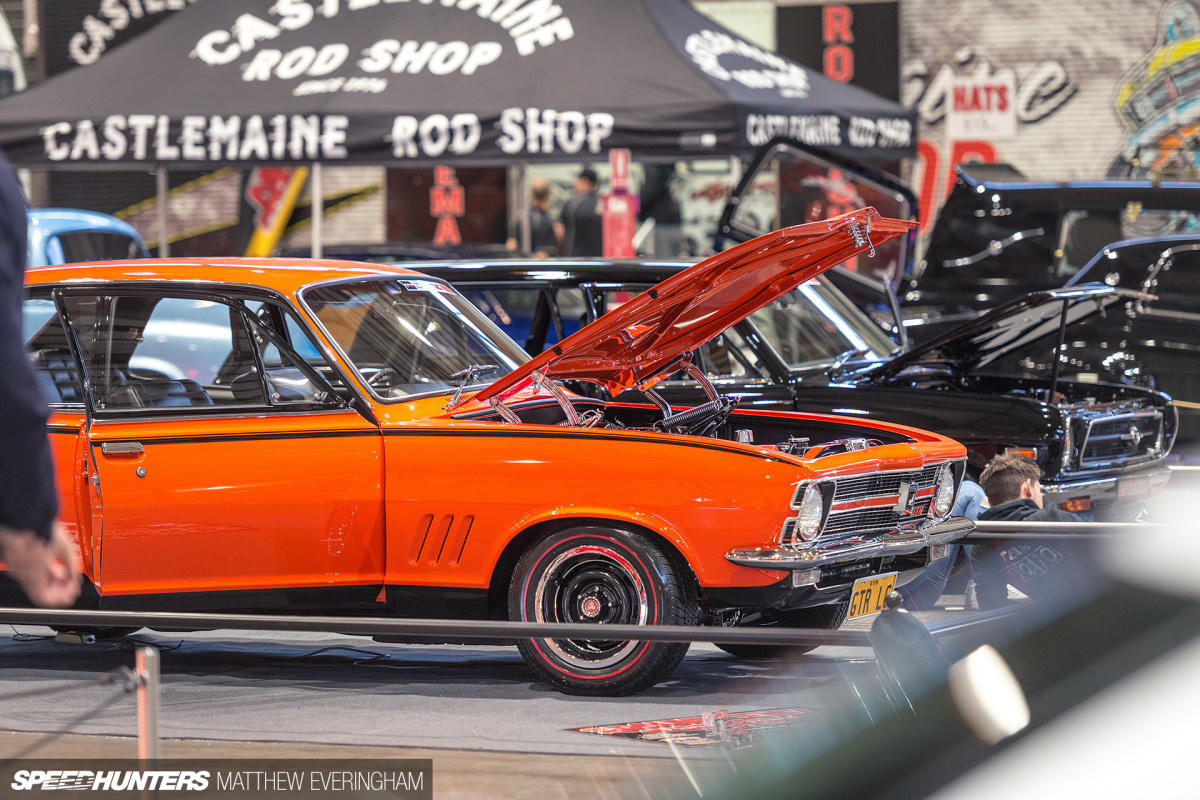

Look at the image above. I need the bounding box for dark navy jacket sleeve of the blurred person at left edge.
[0,154,58,541]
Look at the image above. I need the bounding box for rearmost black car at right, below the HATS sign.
[902,164,1200,339]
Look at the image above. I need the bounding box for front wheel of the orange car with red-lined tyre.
[509,527,700,697]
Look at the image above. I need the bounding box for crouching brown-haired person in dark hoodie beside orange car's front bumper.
[971,452,1082,610]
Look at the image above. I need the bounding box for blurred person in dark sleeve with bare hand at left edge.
[0,154,79,606]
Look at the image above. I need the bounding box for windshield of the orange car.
[301,277,529,401]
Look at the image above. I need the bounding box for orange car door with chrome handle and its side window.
[61,285,384,607]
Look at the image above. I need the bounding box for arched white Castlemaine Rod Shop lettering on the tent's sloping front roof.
[190,0,571,74]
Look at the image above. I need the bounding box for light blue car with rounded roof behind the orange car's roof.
[25,209,150,269]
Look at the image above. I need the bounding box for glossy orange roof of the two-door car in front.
[25,257,441,294]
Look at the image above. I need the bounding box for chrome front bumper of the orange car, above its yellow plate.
[725,517,974,570]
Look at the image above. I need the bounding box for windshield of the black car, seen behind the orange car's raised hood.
[750,278,896,369]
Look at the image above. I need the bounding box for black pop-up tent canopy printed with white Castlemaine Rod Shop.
[0,0,916,170]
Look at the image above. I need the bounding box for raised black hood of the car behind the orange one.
[859,283,1150,380]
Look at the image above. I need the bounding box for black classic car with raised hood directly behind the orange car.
[419,259,1176,519]
